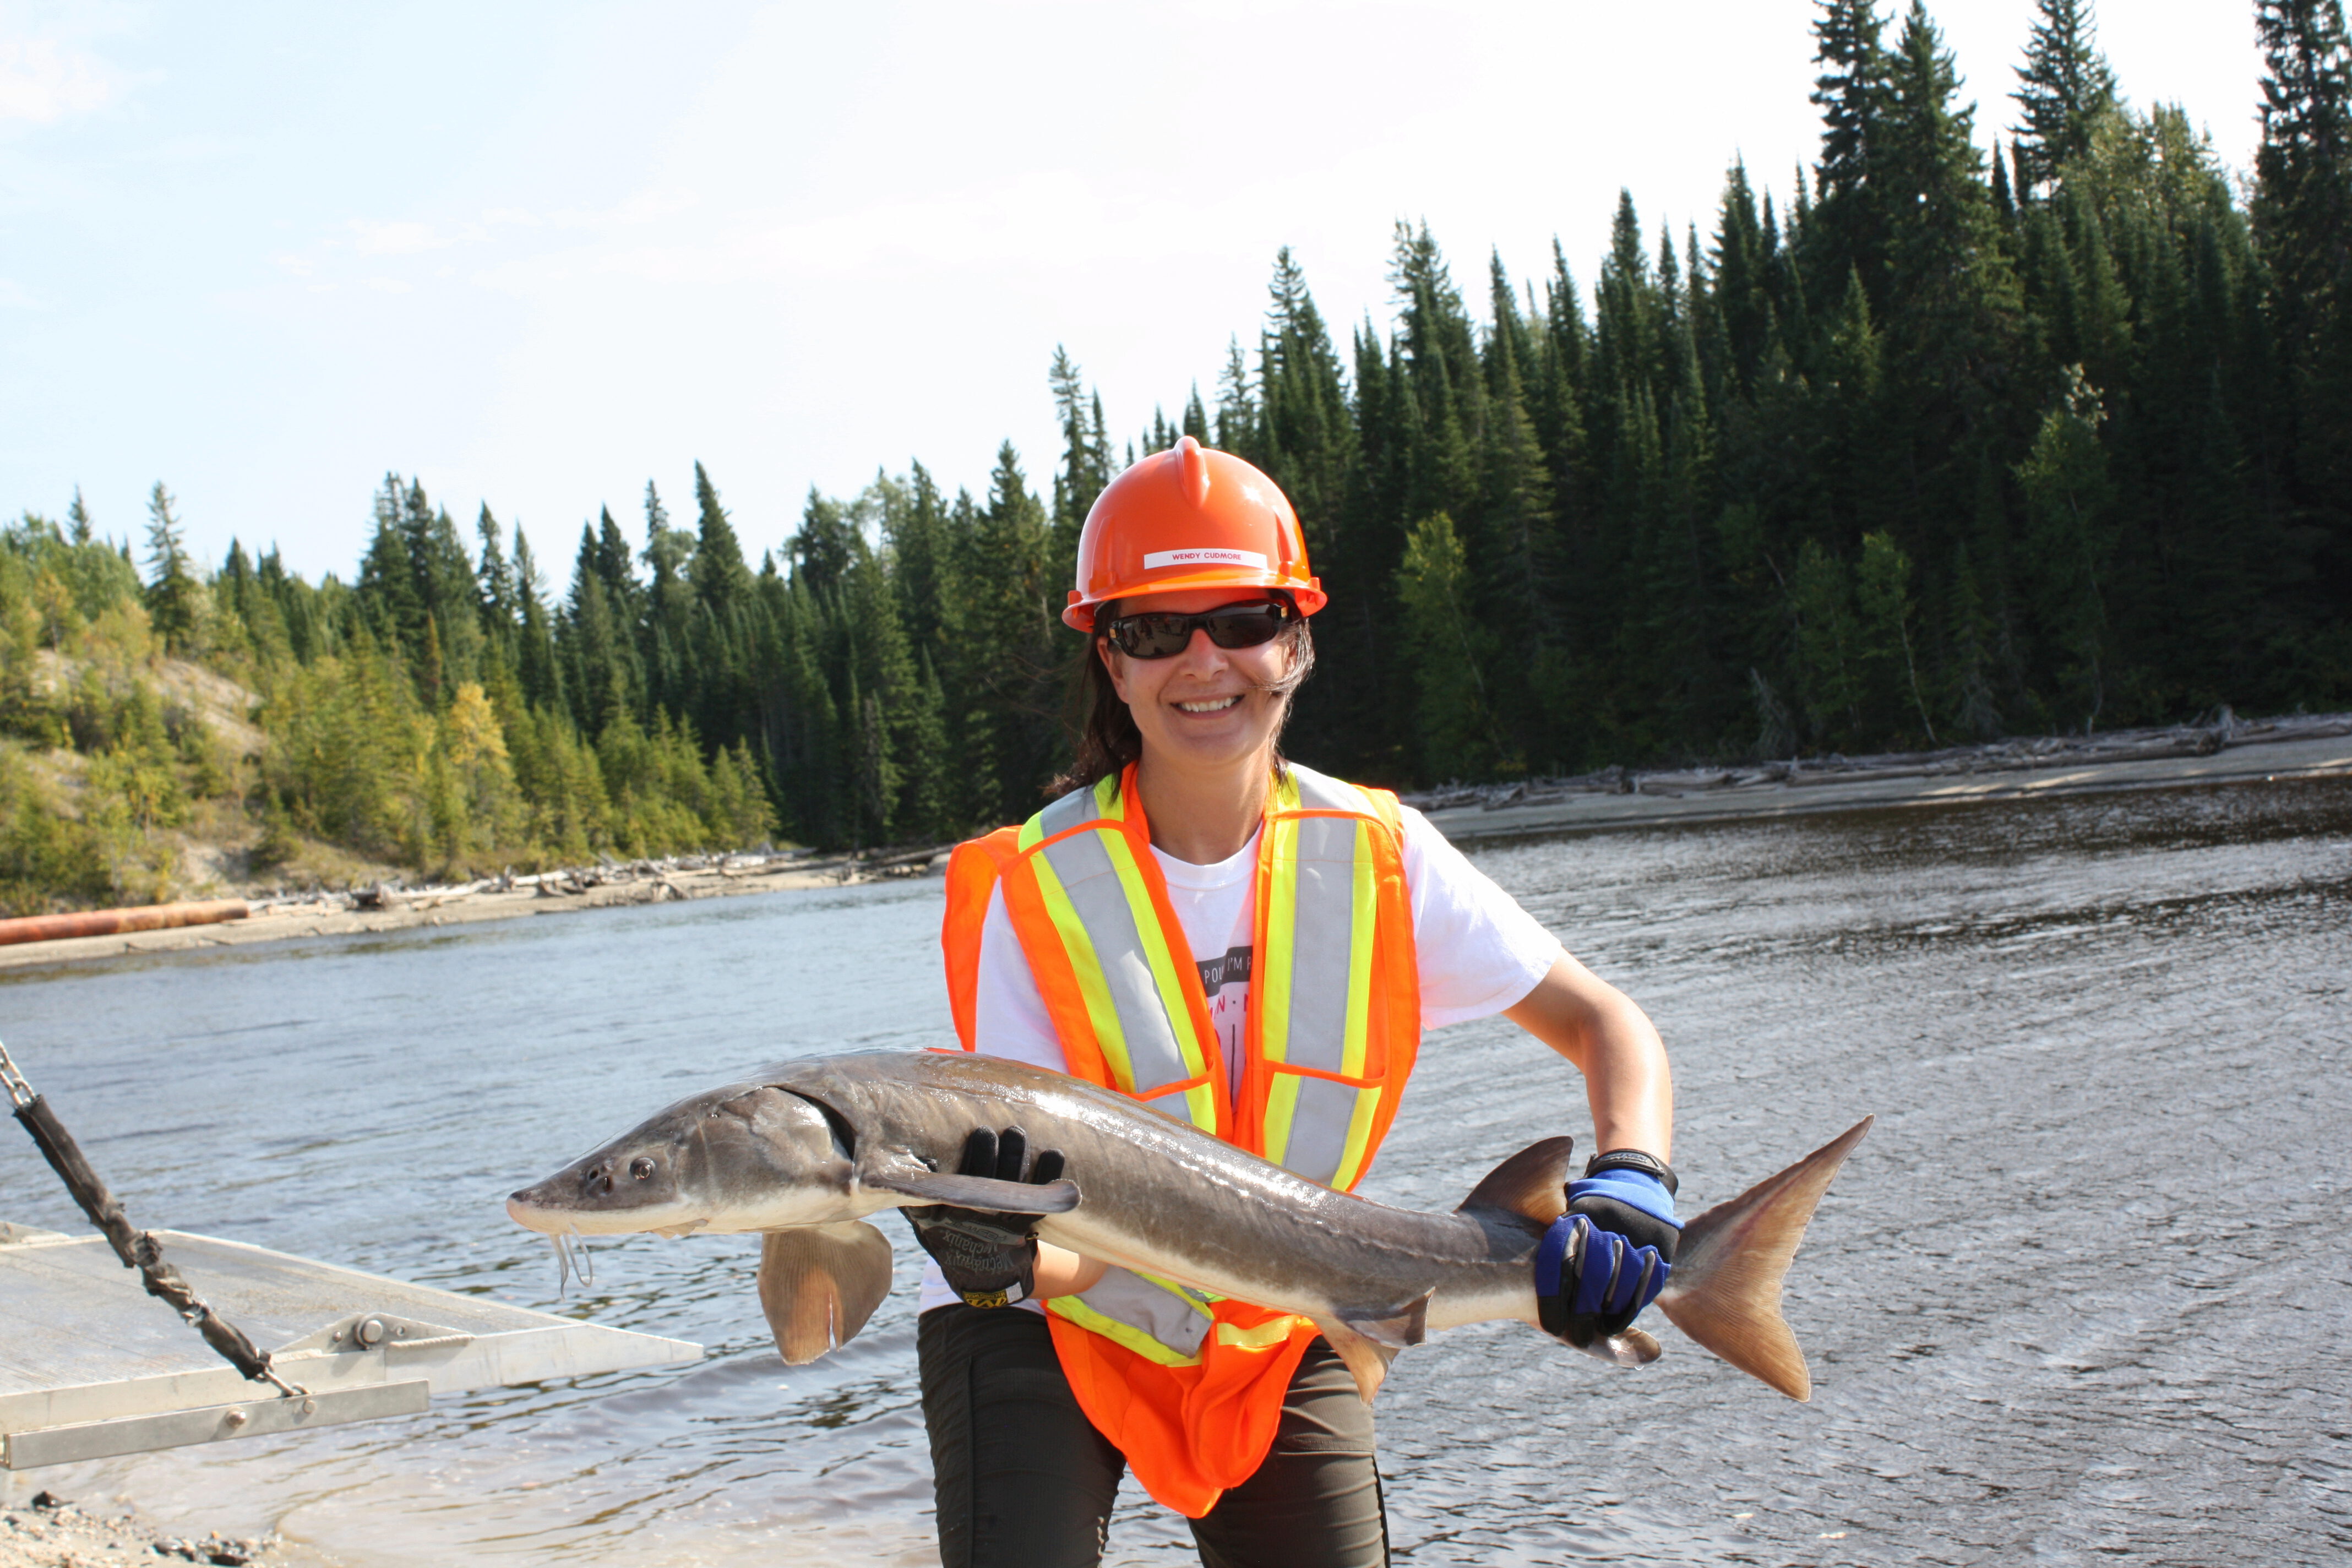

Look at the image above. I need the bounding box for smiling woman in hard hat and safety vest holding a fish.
[910,437,1677,1568]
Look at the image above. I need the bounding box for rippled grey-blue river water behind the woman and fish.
[0,783,2352,1568]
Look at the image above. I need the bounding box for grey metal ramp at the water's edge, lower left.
[0,1222,703,1469]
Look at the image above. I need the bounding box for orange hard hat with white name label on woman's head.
[1061,435,1329,633]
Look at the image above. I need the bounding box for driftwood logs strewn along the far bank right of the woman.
[1402,707,2352,811]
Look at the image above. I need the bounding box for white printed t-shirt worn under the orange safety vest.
[919,764,1562,1312]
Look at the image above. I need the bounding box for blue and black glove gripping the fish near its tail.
[1536,1150,1681,1347]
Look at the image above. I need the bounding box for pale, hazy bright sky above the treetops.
[0,0,2260,578]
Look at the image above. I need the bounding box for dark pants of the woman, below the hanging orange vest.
[915,1305,1387,1568]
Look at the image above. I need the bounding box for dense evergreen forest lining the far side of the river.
[0,0,2352,914]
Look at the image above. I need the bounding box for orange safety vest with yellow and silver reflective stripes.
[941,764,1420,1518]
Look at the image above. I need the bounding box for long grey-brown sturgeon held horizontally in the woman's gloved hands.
[505,1051,1870,1403]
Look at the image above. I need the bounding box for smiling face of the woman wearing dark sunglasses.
[1093,587,1291,769]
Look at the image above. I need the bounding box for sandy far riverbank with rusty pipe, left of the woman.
[0,848,939,971]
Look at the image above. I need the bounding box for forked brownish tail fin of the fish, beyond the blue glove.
[1658,1117,1875,1401]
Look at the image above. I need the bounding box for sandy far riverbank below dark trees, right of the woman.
[1407,710,2352,842]
